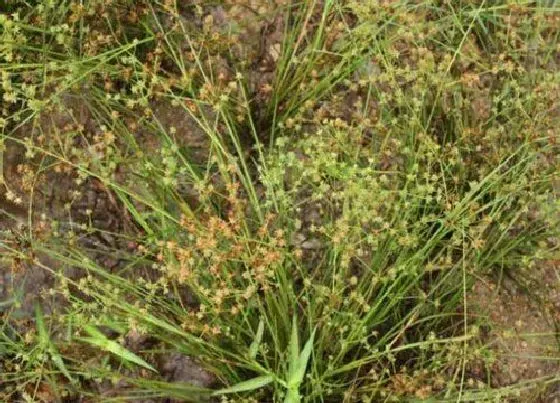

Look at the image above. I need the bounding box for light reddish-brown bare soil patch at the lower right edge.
[470,261,560,402]
